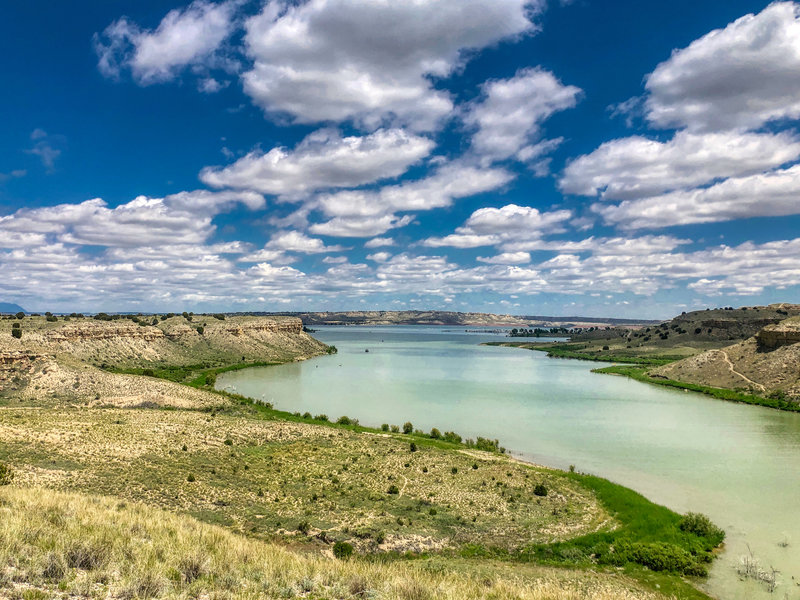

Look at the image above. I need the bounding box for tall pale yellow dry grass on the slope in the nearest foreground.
[0,487,659,600]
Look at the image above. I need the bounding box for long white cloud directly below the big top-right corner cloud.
[559,131,800,200]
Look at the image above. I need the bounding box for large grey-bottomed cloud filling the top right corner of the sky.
[645,2,800,131]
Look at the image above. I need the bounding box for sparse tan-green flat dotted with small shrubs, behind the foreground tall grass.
[0,407,611,551]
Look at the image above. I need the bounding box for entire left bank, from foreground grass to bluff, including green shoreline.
[0,317,720,600]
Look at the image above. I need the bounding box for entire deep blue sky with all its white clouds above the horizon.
[0,0,800,318]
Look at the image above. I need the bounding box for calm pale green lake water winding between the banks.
[218,326,800,599]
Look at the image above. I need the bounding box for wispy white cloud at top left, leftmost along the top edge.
[94,0,241,84]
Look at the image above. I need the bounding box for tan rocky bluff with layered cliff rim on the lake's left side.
[0,315,325,367]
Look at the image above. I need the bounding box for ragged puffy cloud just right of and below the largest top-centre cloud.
[463,68,581,163]
